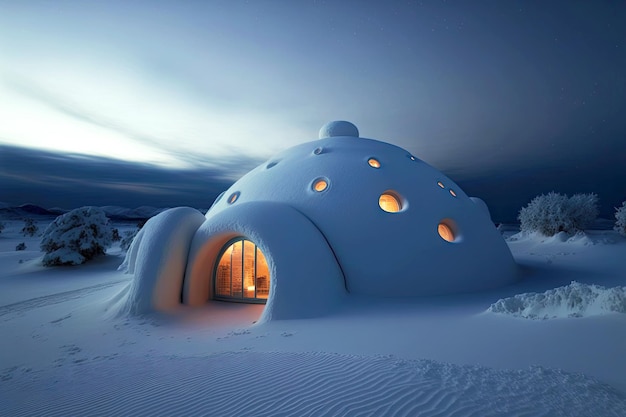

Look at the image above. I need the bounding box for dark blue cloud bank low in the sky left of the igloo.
[0,145,260,208]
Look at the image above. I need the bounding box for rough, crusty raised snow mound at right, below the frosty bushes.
[487,281,626,320]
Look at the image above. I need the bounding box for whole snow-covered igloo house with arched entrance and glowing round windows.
[118,121,517,321]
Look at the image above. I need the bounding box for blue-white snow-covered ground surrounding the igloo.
[0,219,626,416]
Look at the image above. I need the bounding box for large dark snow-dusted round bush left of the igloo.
[41,207,113,266]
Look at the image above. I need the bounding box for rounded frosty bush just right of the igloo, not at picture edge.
[518,192,598,236]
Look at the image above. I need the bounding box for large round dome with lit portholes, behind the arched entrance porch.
[206,122,513,296]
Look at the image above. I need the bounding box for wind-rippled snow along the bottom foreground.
[0,352,626,417]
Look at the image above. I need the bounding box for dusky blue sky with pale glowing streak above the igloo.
[0,0,626,221]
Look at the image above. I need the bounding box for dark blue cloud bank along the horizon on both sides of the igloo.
[0,141,626,222]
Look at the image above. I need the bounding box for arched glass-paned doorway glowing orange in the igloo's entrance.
[213,237,270,303]
